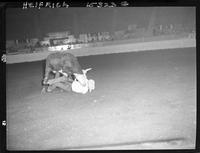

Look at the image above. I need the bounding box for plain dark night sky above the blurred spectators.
[6,7,195,40]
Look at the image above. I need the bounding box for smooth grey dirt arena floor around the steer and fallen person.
[6,48,196,150]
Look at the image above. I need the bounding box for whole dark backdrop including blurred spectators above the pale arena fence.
[6,7,196,53]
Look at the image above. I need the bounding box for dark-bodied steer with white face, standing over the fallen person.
[42,52,86,92]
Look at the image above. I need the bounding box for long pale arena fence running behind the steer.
[6,37,196,64]
